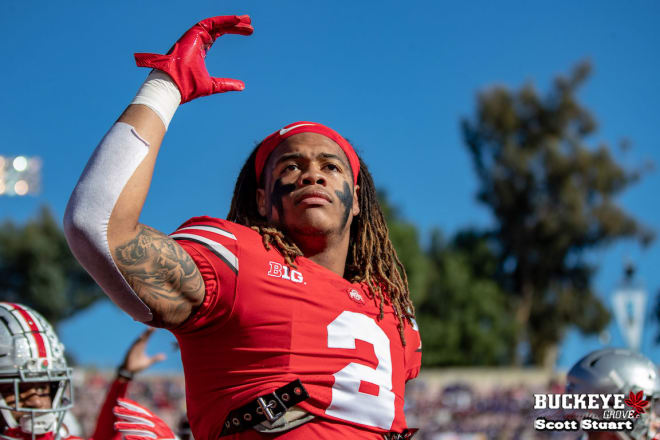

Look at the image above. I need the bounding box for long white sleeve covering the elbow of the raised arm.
[64,122,152,322]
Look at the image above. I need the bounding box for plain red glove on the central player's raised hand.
[135,15,254,104]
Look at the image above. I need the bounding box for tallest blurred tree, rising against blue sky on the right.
[462,63,653,364]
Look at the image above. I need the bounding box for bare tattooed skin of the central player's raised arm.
[108,105,204,328]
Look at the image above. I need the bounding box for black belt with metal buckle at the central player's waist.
[220,379,309,437]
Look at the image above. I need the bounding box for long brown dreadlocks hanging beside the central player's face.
[227,144,415,345]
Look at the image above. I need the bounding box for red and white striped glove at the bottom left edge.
[112,398,176,440]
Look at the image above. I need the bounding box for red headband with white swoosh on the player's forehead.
[254,121,360,185]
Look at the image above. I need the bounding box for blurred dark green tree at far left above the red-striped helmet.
[0,207,105,325]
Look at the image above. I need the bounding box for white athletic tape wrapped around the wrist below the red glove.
[131,69,181,129]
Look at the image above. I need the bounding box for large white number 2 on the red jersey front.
[325,311,394,430]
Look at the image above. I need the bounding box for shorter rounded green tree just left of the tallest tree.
[417,231,516,366]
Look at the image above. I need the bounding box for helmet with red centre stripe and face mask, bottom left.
[0,302,73,439]
